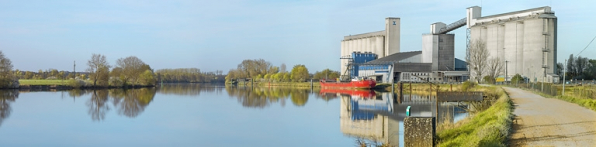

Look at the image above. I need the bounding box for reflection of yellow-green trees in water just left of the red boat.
[226,87,310,108]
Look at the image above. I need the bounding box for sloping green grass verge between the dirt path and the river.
[437,87,513,146]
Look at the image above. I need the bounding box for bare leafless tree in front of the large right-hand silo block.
[467,40,488,83]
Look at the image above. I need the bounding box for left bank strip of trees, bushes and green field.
[0,50,225,90]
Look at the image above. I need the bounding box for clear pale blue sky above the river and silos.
[0,0,596,73]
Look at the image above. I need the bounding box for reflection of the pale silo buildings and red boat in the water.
[321,90,465,146]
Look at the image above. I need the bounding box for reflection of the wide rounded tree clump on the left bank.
[110,88,156,117]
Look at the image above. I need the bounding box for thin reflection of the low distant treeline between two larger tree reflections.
[158,83,221,96]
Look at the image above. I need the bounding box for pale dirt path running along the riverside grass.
[504,87,596,147]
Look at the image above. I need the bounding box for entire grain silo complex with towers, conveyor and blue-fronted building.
[341,6,559,83]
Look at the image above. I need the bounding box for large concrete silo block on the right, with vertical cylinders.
[467,6,559,83]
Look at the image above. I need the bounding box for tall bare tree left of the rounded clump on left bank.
[87,54,110,86]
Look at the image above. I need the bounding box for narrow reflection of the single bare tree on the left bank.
[87,89,110,121]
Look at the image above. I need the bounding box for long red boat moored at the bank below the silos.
[320,79,377,89]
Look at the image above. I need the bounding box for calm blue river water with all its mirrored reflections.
[0,84,467,147]
